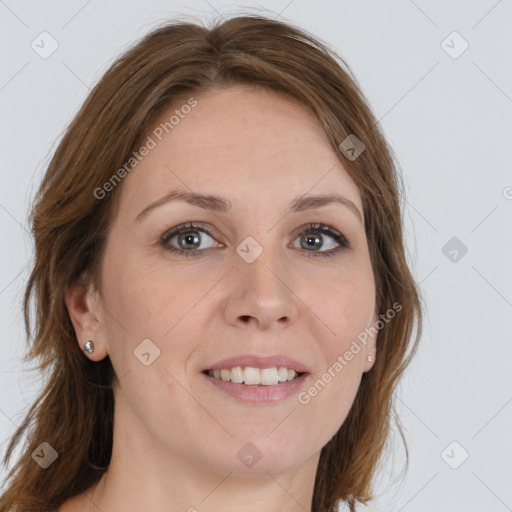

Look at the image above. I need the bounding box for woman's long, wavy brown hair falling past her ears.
[0,15,422,512]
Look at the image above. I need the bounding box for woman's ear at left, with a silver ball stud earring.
[64,276,108,361]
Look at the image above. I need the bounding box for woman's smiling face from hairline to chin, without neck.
[81,86,377,474]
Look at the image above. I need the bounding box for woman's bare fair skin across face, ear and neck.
[59,85,378,512]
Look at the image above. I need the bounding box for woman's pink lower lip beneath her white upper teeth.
[201,373,309,403]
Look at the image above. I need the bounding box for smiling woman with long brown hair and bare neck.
[0,12,422,512]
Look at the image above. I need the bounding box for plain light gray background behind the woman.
[0,0,512,512]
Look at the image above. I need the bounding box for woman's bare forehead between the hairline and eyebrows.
[116,85,362,218]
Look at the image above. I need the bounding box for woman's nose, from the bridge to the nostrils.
[224,246,301,331]
